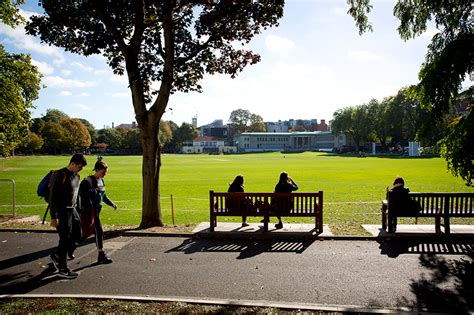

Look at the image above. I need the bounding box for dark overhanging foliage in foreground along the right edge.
[348,0,474,179]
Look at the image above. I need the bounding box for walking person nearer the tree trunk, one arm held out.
[79,156,117,264]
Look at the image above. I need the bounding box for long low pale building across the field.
[234,131,348,152]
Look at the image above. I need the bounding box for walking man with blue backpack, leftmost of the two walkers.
[49,153,87,279]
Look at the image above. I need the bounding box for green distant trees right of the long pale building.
[331,88,472,151]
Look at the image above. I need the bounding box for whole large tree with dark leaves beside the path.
[26,0,283,228]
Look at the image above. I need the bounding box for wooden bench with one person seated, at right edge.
[382,192,474,234]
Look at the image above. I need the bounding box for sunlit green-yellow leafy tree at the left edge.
[0,44,41,156]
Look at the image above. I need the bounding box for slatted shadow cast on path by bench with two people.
[166,239,313,259]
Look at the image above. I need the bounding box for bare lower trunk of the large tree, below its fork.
[140,119,163,229]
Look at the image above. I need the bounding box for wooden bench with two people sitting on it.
[209,190,323,233]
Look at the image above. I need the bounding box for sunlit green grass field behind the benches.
[0,152,473,233]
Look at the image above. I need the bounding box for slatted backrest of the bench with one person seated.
[388,192,474,216]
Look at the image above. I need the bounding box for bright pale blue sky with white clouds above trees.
[0,0,470,129]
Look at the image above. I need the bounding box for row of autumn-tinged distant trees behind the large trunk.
[17,109,197,154]
